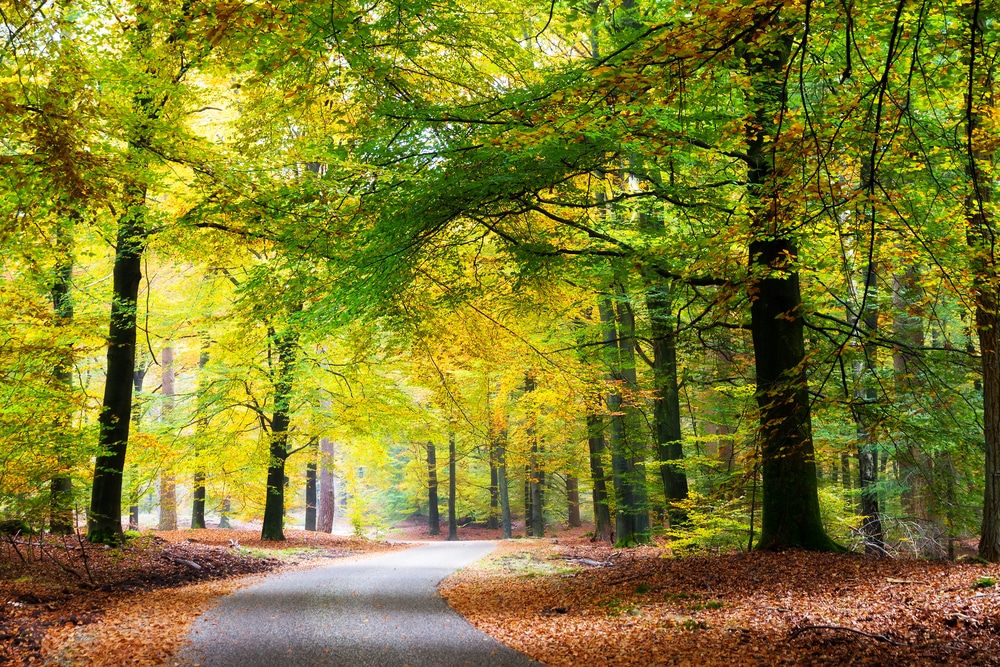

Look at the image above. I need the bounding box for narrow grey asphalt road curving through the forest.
[178,542,540,667]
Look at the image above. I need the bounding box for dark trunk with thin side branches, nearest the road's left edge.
[260,324,301,540]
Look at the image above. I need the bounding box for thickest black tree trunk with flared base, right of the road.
[743,20,839,551]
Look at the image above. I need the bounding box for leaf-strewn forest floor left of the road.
[0,529,404,666]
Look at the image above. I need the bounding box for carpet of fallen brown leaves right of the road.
[442,540,1000,667]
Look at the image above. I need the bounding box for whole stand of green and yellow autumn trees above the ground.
[0,0,1000,563]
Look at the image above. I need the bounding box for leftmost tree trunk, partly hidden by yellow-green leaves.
[49,227,79,535]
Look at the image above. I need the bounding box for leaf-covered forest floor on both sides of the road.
[0,522,1000,667]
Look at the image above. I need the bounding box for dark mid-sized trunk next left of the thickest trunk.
[646,285,687,525]
